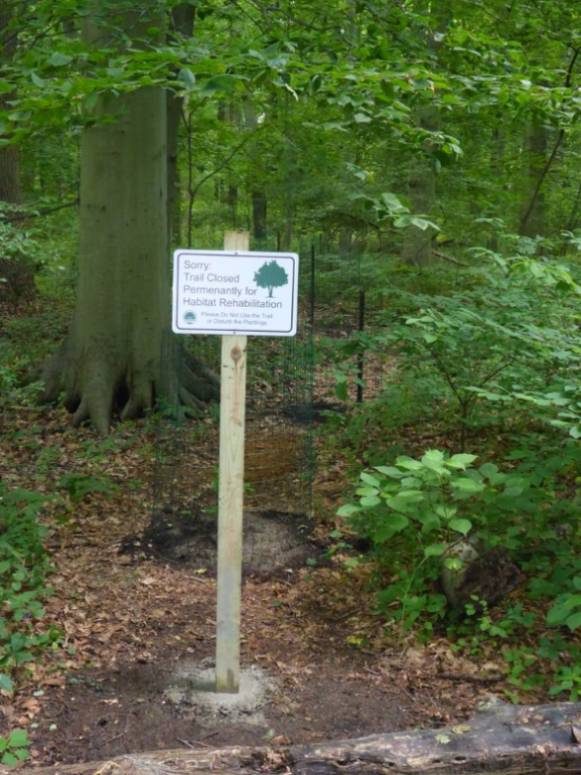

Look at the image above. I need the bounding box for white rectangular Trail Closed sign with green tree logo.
[172,250,299,336]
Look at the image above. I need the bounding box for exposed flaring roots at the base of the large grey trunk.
[43,339,220,435]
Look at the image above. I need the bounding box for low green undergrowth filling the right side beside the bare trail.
[324,238,581,700]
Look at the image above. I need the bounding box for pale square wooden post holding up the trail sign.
[216,231,248,693]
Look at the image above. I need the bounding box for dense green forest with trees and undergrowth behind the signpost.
[0,0,581,764]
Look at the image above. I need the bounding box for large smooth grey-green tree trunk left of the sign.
[45,0,217,433]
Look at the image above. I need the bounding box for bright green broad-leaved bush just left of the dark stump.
[338,450,482,625]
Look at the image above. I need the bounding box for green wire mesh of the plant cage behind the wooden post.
[152,249,315,552]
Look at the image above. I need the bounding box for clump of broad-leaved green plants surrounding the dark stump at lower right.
[338,436,581,699]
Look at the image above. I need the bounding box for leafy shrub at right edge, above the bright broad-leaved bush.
[391,268,580,443]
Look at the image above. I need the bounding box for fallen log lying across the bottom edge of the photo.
[21,703,581,775]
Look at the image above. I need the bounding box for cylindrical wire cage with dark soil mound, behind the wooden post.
[144,249,315,573]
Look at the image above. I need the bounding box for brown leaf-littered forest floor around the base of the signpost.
[0,302,532,765]
